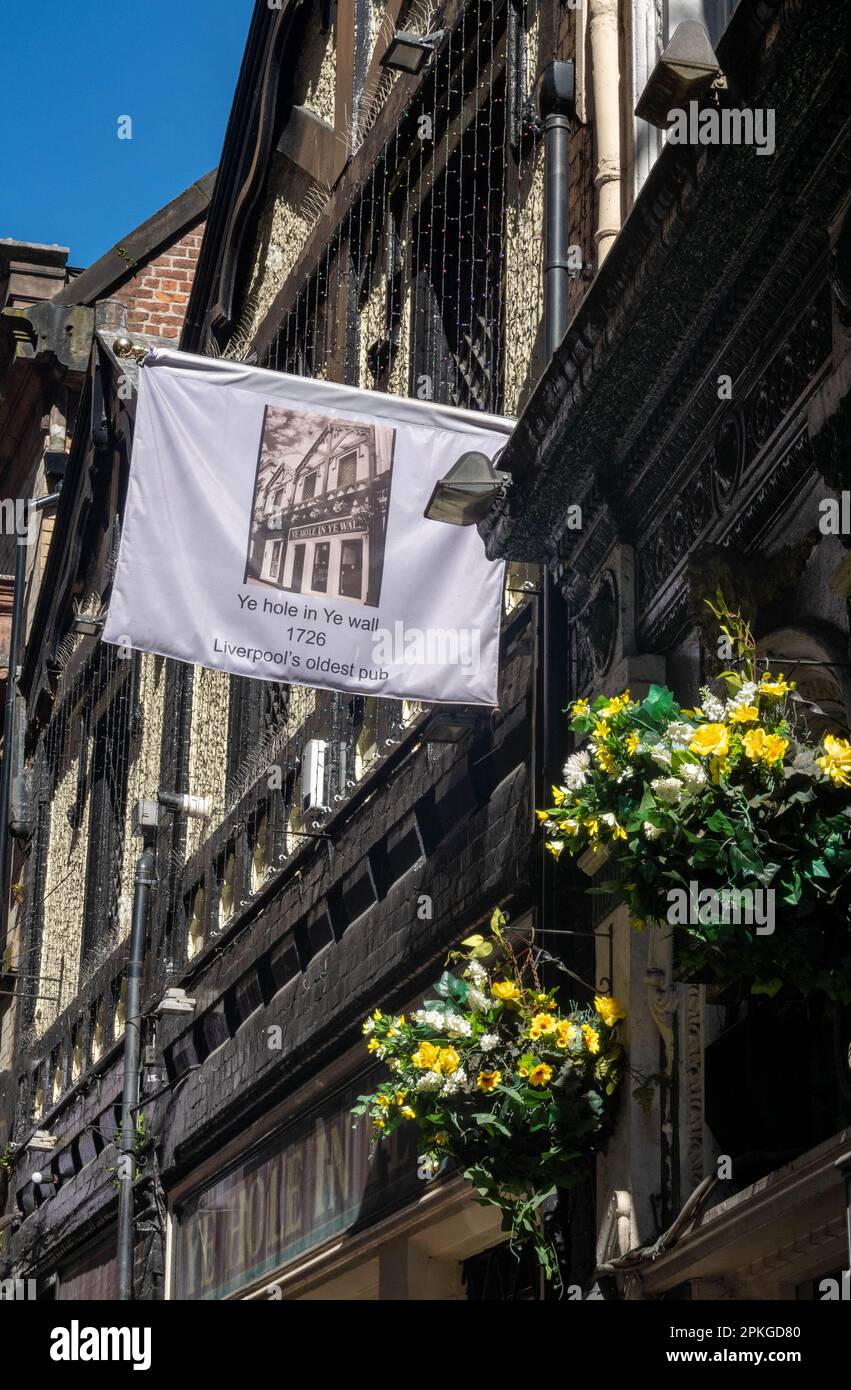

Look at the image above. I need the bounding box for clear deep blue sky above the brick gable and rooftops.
[0,0,253,265]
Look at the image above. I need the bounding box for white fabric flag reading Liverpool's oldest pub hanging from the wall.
[103,349,512,705]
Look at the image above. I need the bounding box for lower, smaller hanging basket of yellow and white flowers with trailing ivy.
[355,912,624,1277]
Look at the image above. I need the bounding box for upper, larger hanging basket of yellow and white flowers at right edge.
[537,595,851,1004]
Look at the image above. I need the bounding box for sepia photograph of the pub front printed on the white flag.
[245,406,395,607]
